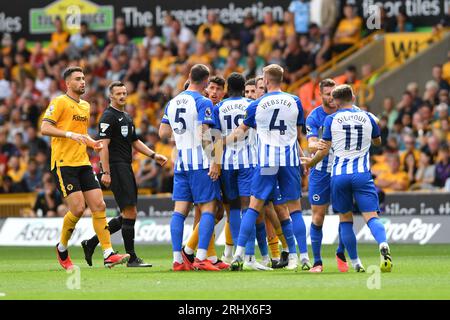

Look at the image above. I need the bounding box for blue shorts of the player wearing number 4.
[252,167,302,204]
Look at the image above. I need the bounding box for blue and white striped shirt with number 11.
[322,108,380,176]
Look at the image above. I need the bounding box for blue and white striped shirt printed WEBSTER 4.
[244,91,304,167]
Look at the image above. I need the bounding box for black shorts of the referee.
[109,163,137,211]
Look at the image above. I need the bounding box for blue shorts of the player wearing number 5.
[172,169,221,204]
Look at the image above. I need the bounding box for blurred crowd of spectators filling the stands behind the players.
[0,1,450,215]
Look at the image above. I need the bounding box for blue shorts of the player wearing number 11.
[331,172,380,213]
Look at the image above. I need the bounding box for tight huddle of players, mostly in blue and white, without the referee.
[159,64,392,272]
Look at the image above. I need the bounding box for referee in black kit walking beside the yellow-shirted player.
[81,81,167,267]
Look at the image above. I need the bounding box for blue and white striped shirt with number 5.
[161,91,215,172]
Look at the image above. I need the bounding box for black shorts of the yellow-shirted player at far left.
[52,166,100,198]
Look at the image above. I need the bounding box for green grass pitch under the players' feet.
[0,245,450,301]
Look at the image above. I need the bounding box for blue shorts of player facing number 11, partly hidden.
[308,169,331,206]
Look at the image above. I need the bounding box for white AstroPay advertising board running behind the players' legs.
[0,215,450,247]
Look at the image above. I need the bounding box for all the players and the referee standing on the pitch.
[41,64,392,272]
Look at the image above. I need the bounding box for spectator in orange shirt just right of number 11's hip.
[375,153,409,193]
